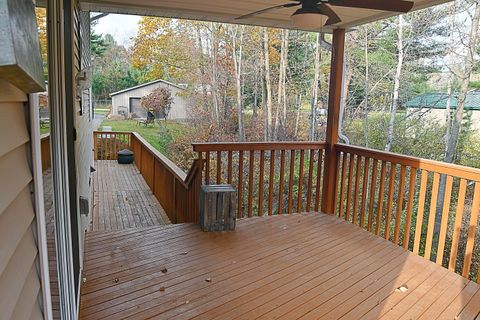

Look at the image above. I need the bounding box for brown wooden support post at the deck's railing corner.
[321,29,345,214]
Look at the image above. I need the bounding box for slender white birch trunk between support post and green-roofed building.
[385,15,405,151]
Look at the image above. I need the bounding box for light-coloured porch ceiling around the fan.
[80,0,448,32]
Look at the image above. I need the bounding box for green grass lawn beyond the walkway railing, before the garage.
[100,120,185,156]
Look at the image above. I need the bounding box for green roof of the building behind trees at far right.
[405,90,480,110]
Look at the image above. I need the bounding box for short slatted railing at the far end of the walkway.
[93,131,132,160]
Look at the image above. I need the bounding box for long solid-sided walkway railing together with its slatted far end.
[93,131,201,223]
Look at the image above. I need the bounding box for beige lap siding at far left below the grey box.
[0,79,43,319]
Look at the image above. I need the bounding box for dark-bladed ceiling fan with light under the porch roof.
[235,0,414,30]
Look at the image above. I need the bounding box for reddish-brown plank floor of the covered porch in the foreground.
[80,214,480,319]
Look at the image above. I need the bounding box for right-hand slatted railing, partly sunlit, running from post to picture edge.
[335,144,480,280]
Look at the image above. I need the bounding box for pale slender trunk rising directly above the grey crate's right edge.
[232,25,245,141]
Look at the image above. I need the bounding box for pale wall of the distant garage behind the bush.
[112,82,187,120]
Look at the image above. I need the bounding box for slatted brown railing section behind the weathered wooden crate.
[193,142,325,218]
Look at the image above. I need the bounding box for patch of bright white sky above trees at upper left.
[94,14,141,47]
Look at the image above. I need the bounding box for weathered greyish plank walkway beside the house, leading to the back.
[92,160,170,231]
